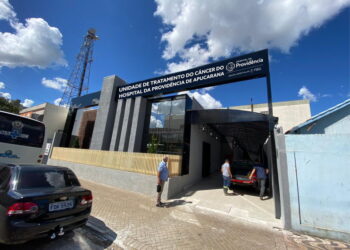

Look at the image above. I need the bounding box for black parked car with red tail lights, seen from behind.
[0,164,92,244]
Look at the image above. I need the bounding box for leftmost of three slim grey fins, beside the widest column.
[109,99,126,151]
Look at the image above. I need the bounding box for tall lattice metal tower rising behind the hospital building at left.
[59,29,98,106]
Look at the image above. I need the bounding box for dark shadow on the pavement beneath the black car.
[0,217,117,250]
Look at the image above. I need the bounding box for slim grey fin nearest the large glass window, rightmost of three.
[128,96,147,152]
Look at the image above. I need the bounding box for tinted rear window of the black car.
[17,168,80,189]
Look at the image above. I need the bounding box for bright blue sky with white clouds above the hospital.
[0,0,350,114]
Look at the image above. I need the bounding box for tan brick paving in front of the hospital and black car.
[81,180,350,249]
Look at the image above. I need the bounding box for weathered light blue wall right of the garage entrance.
[279,134,350,241]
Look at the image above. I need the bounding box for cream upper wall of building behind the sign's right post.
[230,100,311,132]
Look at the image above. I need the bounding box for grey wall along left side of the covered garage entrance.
[168,125,223,197]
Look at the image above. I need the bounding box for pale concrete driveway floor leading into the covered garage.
[172,173,281,227]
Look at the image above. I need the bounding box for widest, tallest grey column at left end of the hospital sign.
[90,75,125,150]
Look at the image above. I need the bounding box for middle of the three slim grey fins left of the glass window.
[118,98,135,152]
